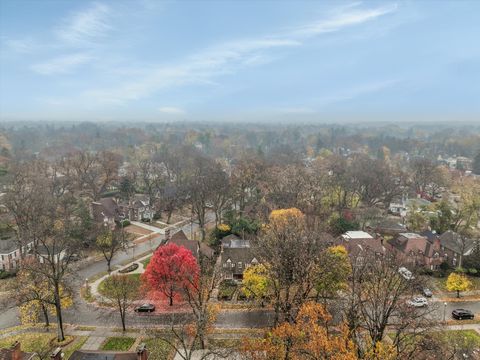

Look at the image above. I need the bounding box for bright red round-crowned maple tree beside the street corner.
[143,244,199,306]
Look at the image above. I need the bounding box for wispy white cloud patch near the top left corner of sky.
[56,3,112,45]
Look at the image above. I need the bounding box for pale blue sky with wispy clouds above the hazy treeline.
[0,0,480,121]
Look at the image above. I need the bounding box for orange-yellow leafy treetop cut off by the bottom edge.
[242,302,357,360]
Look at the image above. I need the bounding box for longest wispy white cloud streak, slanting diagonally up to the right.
[79,4,397,104]
